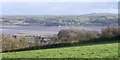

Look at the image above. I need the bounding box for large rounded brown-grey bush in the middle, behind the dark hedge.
[58,29,99,43]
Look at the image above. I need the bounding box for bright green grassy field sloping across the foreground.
[2,43,118,58]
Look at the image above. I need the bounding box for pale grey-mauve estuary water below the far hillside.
[0,25,106,35]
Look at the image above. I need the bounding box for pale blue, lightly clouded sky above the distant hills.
[0,0,118,15]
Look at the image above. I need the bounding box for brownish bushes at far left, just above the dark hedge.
[0,34,41,51]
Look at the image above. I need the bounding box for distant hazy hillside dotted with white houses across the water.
[0,13,118,26]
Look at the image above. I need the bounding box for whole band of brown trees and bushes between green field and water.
[0,27,120,51]
